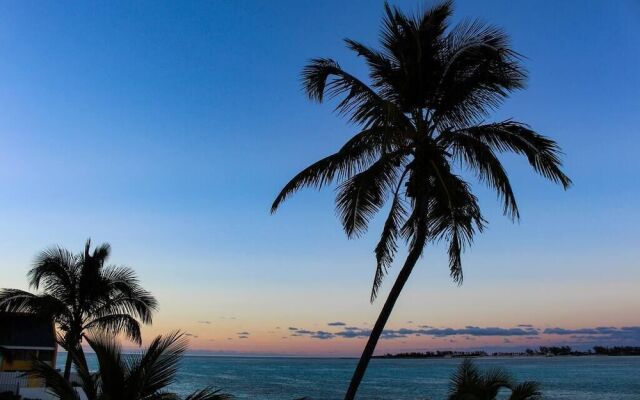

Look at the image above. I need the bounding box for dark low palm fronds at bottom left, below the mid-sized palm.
[33,332,233,400]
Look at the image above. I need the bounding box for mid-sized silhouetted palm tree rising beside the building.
[0,240,157,379]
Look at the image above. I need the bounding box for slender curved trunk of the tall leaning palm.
[344,232,426,400]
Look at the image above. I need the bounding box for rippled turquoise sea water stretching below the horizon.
[60,355,640,400]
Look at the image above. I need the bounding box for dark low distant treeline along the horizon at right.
[374,346,640,358]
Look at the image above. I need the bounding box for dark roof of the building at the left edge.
[0,313,56,348]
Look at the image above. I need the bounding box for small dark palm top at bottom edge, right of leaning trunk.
[449,359,541,400]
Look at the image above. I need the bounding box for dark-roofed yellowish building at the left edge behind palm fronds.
[0,313,57,384]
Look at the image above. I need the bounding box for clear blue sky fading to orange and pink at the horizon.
[0,0,640,356]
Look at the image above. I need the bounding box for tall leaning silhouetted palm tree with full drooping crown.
[271,1,571,400]
